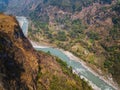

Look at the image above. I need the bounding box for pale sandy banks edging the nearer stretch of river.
[32,42,119,90]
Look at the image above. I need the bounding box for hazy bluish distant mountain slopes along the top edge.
[0,0,112,15]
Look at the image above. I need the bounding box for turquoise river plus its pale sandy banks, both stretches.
[17,17,118,90]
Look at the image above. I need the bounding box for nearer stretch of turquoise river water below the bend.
[36,48,115,90]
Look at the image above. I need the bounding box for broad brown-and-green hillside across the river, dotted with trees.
[29,0,120,86]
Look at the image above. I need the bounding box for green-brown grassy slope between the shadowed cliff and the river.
[37,52,92,90]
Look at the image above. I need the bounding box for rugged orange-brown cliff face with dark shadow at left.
[0,14,38,90]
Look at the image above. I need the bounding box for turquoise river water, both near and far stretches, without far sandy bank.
[17,17,117,90]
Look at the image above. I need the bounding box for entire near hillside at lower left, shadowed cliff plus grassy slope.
[0,14,92,90]
